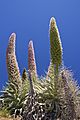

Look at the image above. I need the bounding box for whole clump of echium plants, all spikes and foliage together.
[1,17,80,120]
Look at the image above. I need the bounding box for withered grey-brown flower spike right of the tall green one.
[61,70,76,120]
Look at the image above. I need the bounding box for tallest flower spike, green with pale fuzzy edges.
[50,17,62,73]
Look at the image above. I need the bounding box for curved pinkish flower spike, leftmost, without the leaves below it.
[6,33,21,83]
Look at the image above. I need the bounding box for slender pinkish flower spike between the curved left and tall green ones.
[28,41,37,77]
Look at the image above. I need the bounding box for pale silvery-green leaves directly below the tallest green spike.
[34,76,60,120]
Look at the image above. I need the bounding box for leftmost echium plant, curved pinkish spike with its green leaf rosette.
[1,33,29,115]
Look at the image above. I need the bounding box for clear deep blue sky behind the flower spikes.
[0,0,80,89]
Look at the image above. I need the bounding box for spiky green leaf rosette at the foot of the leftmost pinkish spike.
[1,81,22,115]
